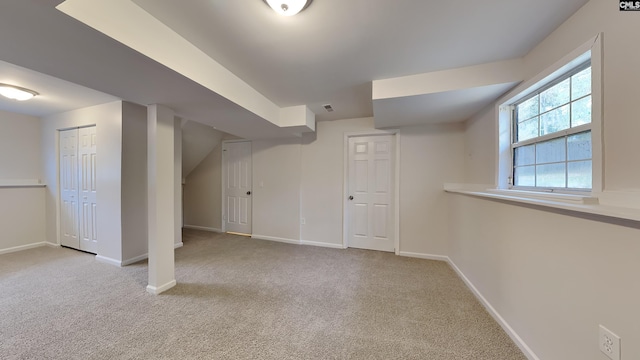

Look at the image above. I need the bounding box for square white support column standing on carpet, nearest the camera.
[147,105,176,295]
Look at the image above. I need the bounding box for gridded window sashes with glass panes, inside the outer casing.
[511,61,592,190]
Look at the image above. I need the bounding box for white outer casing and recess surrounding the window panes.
[496,33,604,195]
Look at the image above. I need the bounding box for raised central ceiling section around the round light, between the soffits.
[133,0,586,120]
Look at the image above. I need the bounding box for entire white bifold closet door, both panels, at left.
[59,126,98,254]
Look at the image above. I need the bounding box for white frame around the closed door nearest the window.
[342,129,400,255]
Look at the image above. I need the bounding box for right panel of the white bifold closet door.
[78,126,98,253]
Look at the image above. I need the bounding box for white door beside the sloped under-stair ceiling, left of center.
[222,141,252,235]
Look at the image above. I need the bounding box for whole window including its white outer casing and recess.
[496,34,604,198]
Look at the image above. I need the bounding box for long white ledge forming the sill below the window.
[444,184,640,222]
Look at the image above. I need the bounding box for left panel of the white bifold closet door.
[59,129,80,249]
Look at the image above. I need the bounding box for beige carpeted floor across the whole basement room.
[0,231,526,360]
